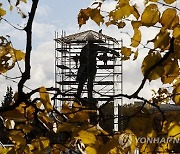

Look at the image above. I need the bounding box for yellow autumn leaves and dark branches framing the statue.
[0,0,180,154]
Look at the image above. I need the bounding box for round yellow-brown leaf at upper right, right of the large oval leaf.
[160,8,179,29]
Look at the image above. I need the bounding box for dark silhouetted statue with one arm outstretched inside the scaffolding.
[76,35,119,100]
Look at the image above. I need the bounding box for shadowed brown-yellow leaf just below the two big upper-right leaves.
[154,28,170,50]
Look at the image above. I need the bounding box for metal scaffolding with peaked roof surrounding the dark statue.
[55,30,122,131]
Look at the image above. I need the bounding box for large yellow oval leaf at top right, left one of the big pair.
[141,4,160,27]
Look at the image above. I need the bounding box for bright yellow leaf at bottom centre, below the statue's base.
[78,130,96,145]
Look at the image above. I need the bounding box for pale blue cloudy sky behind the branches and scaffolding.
[0,0,166,103]
